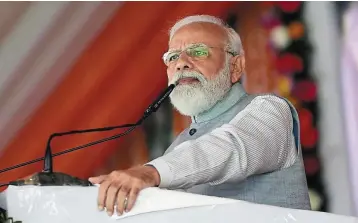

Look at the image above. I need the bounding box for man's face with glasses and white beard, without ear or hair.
[165,23,232,116]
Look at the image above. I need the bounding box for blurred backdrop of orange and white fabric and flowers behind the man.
[0,2,358,216]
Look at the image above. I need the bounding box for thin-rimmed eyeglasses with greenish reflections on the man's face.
[163,44,237,66]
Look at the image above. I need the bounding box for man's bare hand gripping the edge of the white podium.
[89,166,160,216]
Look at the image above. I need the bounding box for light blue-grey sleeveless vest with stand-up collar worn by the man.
[165,83,311,210]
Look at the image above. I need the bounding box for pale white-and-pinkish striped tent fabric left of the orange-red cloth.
[0,2,121,152]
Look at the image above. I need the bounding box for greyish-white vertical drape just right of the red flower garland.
[304,1,353,215]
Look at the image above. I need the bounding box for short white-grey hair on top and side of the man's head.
[169,15,244,55]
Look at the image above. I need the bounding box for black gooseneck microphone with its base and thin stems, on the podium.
[0,82,178,187]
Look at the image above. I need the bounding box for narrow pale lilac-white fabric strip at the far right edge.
[340,2,358,216]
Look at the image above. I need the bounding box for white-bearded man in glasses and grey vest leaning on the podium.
[90,15,310,215]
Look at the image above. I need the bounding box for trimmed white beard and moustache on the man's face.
[170,59,232,116]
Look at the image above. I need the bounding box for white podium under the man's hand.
[0,186,358,223]
